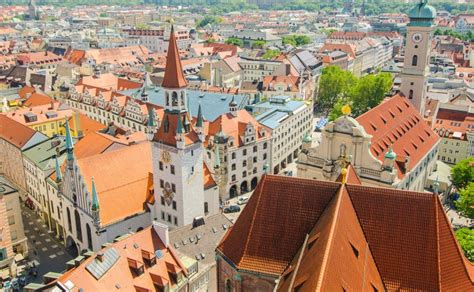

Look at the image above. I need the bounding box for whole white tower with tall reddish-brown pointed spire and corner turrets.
[148,27,205,228]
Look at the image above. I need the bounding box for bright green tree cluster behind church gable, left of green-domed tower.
[317,66,392,120]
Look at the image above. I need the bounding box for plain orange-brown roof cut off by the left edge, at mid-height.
[0,115,36,148]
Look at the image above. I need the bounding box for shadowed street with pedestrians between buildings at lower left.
[22,206,72,282]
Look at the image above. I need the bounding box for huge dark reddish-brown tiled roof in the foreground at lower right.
[218,176,474,291]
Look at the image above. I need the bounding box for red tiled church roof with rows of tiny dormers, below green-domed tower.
[356,94,439,178]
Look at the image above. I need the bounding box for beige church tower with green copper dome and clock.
[401,0,436,116]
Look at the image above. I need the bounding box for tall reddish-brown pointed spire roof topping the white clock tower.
[161,26,188,88]
